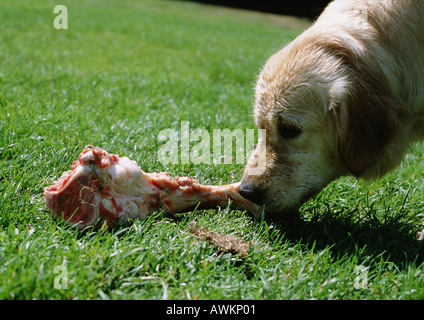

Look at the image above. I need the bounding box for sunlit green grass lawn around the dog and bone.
[0,0,424,299]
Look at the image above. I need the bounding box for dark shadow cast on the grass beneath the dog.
[269,210,424,268]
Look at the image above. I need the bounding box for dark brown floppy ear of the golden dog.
[330,77,404,177]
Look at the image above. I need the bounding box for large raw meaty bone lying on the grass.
[44,145,261,229]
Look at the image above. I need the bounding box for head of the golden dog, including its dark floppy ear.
[239,39,404,219]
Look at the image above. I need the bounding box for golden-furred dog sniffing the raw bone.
[239,0,424,235]
